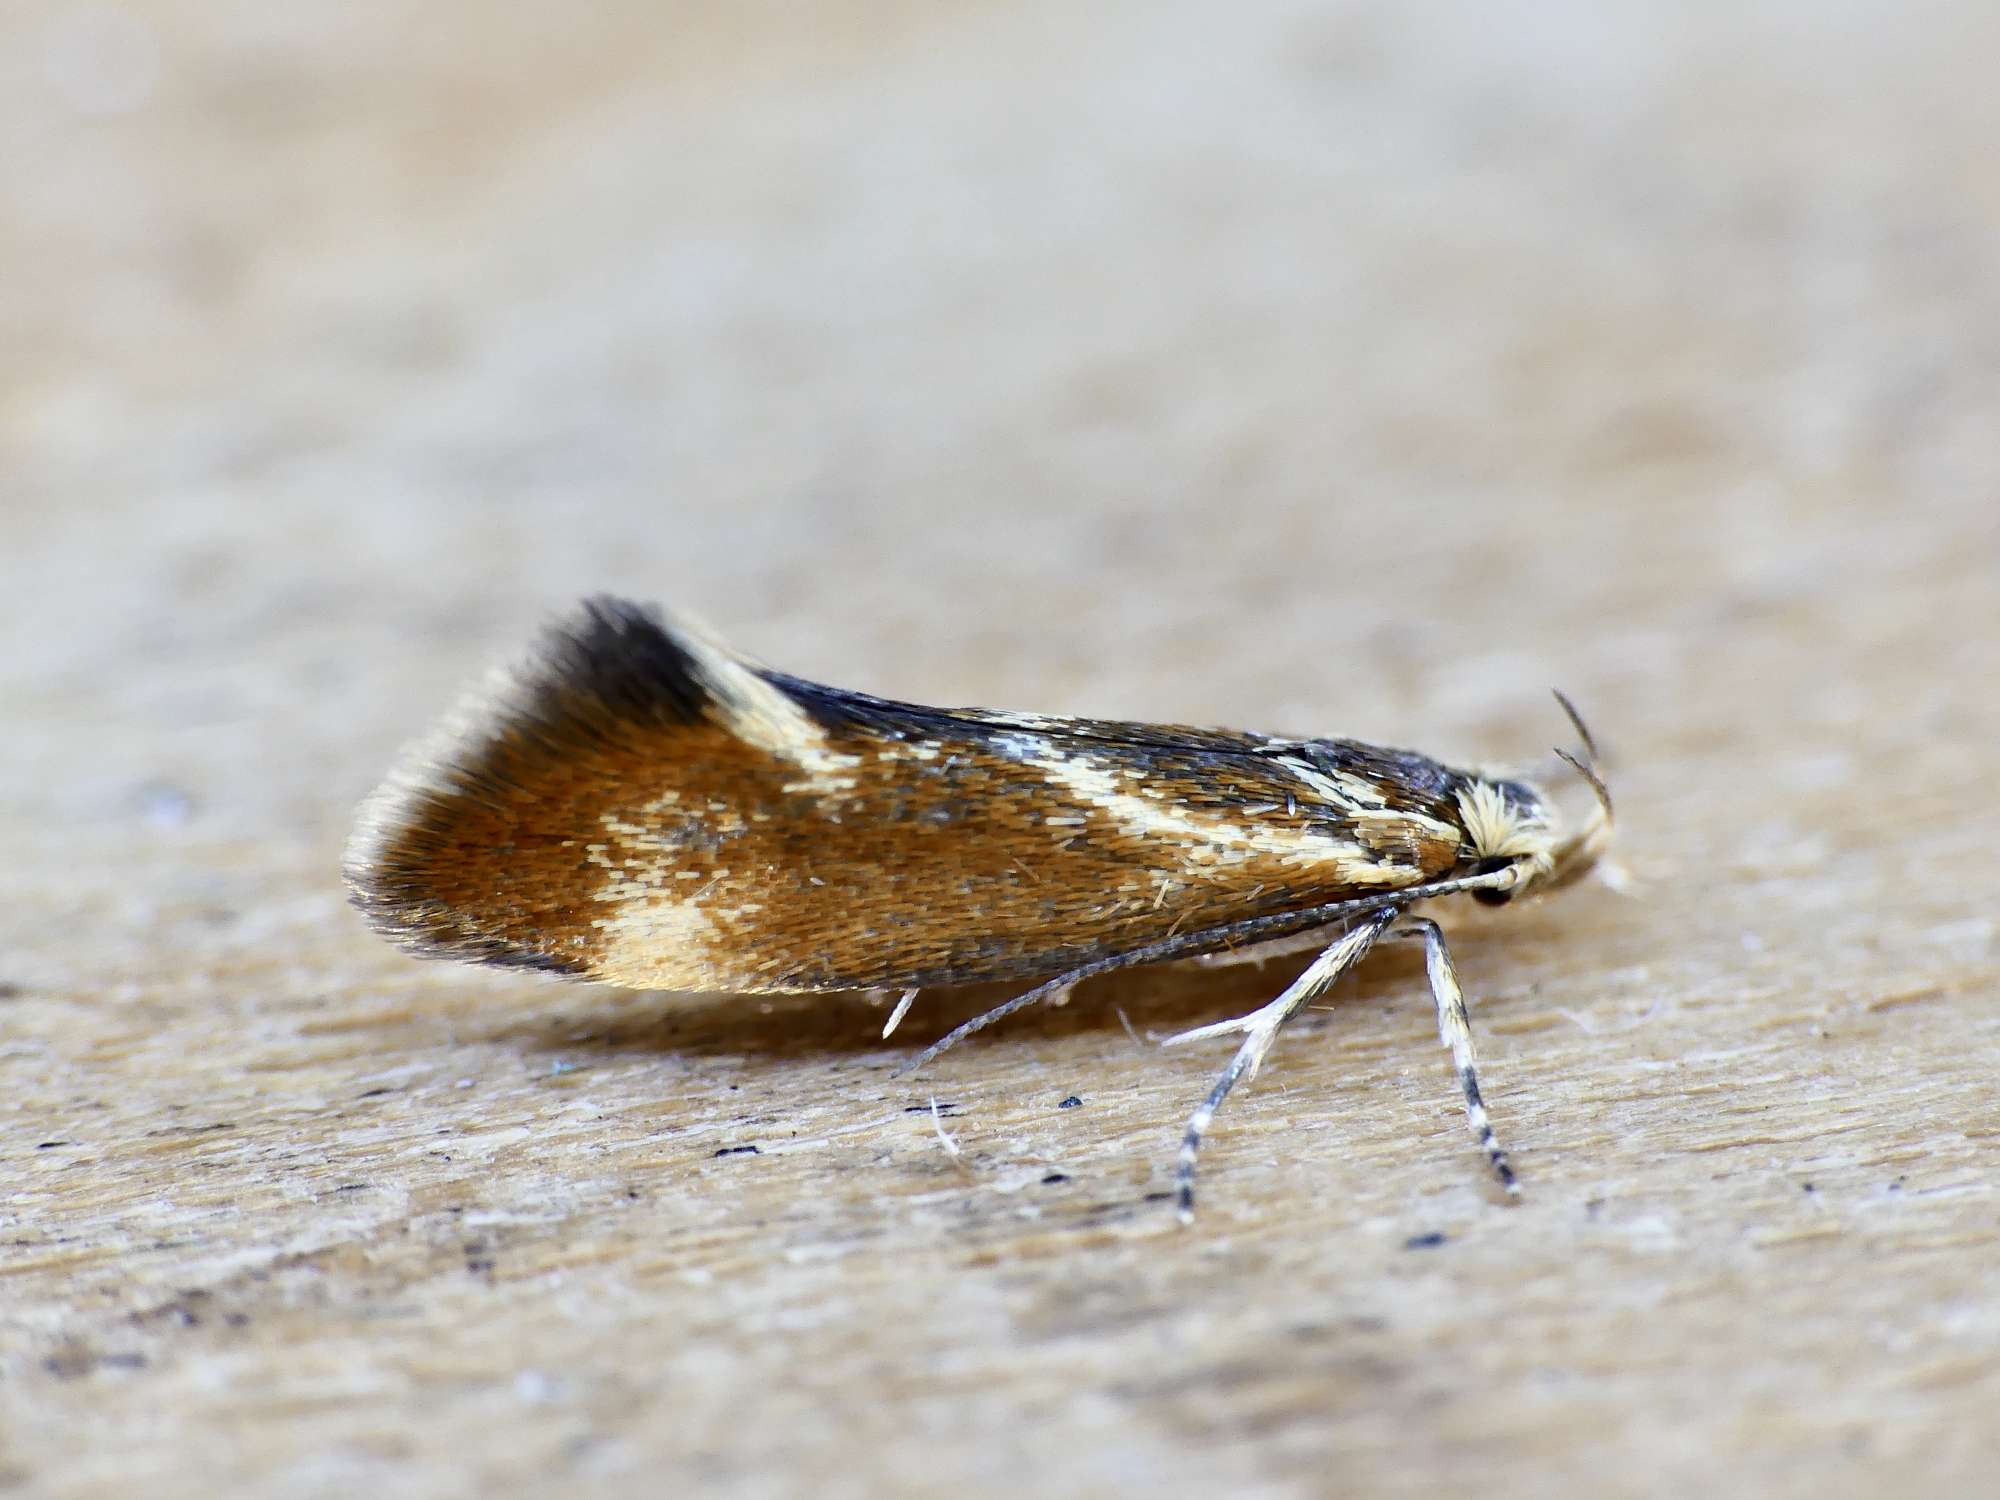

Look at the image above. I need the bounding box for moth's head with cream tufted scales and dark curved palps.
[1458,692,1612,906]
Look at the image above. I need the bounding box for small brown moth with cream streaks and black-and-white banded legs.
[346,598,1612,1220]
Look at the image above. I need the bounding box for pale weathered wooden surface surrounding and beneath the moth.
[0,0,2000,1496]
